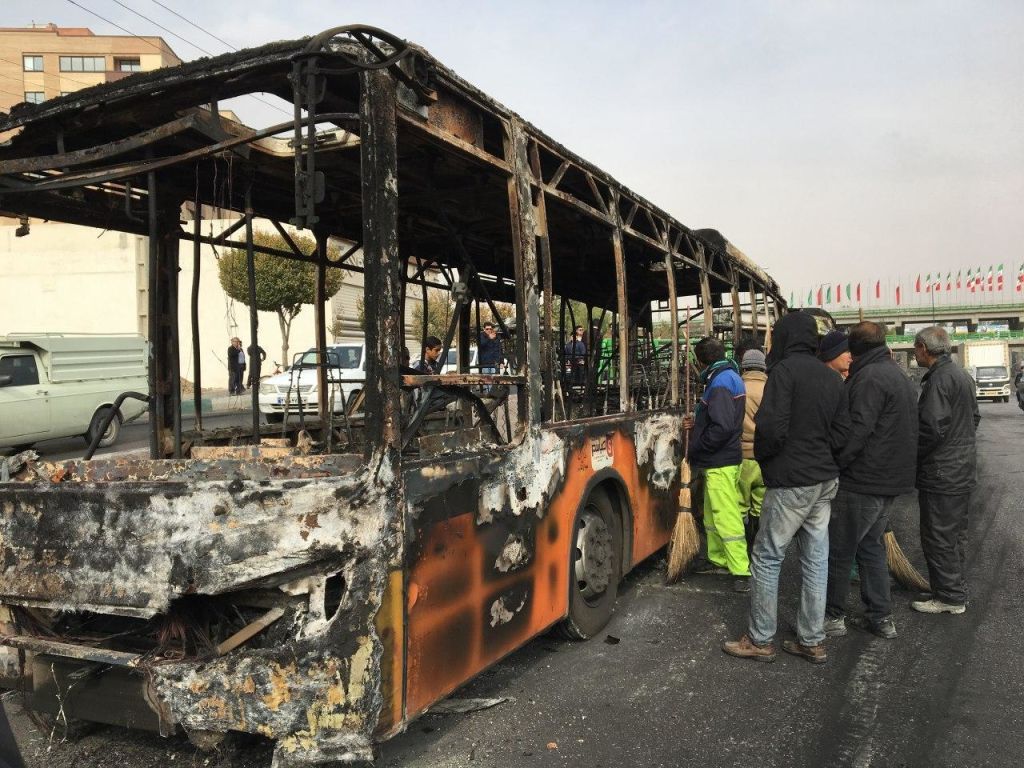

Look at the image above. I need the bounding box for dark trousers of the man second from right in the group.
[825,493,893,624]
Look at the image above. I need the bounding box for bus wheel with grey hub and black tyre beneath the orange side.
[559,490,623,640]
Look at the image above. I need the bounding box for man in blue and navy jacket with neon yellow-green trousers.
[687,337,751,592]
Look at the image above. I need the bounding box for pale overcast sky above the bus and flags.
[8,0,1024,295]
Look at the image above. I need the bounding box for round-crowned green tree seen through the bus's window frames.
[217,230,343,365]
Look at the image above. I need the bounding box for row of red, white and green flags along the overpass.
[790,262,1024,307]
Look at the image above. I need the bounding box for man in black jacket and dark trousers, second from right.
[824,323,918,640]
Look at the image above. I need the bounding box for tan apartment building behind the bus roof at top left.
[0,24,181,112]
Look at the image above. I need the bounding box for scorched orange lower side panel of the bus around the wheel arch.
[406,418,679,719]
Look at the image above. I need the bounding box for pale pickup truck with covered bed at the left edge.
[0,334,148,450]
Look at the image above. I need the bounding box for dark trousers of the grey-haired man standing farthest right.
[918,490,971,605]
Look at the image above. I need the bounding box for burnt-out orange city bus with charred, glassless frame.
[0,26,785,766]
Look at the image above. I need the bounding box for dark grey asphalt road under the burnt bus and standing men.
[8,403,1024,768]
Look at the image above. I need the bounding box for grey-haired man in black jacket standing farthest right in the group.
[910,326,981,613]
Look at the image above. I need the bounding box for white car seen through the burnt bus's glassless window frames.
[259,341,367,424]
